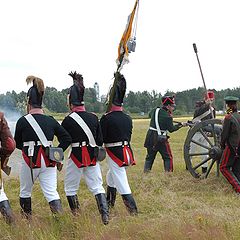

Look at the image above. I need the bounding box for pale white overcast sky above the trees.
[0,0,240,95]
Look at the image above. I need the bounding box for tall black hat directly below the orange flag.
[112,72,127,106]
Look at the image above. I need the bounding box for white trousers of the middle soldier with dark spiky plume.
[64,158,105,196]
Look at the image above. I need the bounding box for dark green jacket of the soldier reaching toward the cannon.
[144,108,182,148]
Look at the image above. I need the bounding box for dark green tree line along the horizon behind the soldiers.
[0,87,240,115]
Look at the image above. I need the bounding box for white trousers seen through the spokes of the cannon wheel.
[189,132,209,167]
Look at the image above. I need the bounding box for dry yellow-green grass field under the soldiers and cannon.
[0,119,240,240]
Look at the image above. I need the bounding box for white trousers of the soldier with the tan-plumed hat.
[20,156,60,202]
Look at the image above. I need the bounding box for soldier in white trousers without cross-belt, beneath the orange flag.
[100,72,138,215]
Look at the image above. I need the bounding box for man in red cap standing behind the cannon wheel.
[190,90,216,173]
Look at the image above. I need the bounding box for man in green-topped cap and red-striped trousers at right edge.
[220,96,240,193]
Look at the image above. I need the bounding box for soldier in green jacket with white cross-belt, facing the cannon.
[144,96,183,173]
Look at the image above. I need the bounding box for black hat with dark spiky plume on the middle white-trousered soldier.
[68,71,85,106]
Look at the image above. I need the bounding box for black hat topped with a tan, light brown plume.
[26,76,44,108]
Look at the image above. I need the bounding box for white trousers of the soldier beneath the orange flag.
[106,154,131,195]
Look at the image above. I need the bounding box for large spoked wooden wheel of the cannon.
[184,119,222,178]
